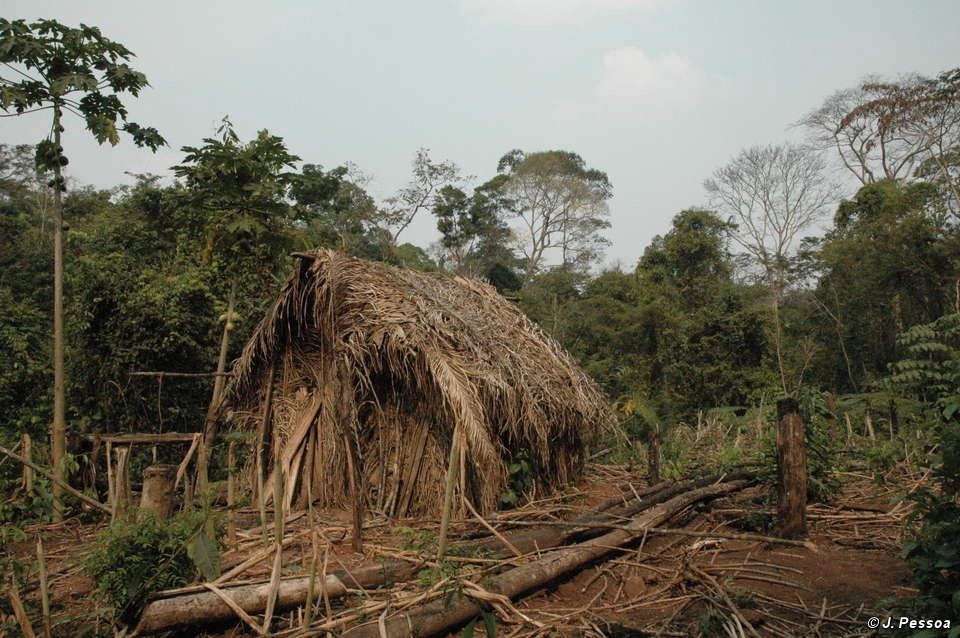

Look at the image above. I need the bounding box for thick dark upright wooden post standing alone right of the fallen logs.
[777,398,807,538]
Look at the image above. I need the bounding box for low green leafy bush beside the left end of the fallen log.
[84,510,218,623]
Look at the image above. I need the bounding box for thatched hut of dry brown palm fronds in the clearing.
[228,250,614,516]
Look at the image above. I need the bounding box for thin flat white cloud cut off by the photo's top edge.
[465,0,666,27]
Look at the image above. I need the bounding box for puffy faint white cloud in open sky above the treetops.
[557,46,706,119]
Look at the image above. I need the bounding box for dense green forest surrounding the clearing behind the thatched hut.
[0,21,960,636]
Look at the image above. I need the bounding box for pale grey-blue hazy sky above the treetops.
[0,0,960,268]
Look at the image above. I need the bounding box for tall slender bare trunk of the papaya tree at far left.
[50,102,67,521]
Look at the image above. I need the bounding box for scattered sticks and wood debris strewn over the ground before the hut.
[1,464,925,637]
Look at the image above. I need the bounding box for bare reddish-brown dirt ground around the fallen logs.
[0,466,918,637]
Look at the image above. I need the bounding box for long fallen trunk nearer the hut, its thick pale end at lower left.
[136,477,748,635]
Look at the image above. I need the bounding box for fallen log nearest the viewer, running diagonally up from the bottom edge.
[343,481,748,638]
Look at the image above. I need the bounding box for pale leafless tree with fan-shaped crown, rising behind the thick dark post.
[704,144,837,392]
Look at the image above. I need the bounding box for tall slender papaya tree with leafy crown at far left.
[0,18,165,517]
